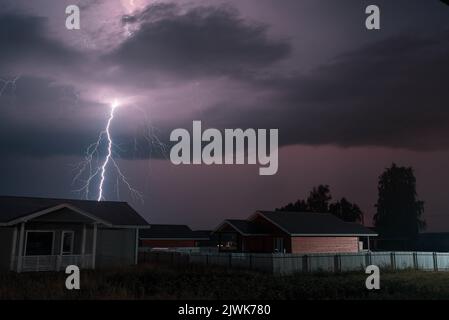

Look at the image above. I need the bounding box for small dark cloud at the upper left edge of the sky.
[0,13,81,68]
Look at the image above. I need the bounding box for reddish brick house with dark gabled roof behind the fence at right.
[214,211,377,253]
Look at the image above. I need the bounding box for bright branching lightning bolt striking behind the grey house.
[72,101,143,202]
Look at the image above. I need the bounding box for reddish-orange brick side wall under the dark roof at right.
[291,237,359,253]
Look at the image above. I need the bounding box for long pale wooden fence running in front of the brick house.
[139,252,449,274]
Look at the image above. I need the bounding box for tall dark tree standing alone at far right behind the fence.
[374,163,426,238]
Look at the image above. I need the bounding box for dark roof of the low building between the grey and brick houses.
[140,224,209,240]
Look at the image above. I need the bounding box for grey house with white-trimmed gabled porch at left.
[0,197,149,272]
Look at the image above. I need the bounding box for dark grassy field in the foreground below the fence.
[0,265,449,300]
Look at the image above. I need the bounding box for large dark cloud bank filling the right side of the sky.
[202,32,449,149]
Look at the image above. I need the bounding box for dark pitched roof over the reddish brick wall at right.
[256,211,377,236]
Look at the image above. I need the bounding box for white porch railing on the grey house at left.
[14,255,92,272]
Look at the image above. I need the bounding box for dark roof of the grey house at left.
[0,196,148,226]
